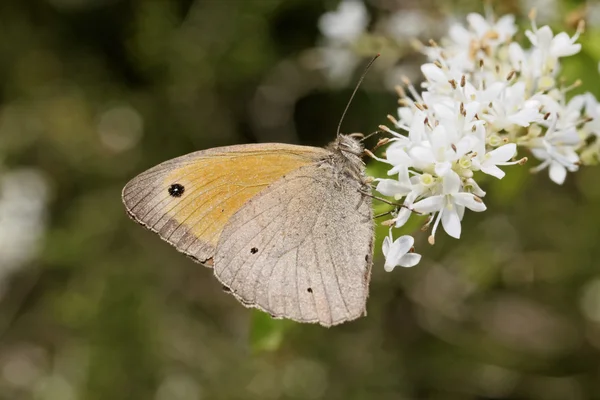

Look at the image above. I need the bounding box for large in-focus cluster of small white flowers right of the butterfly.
[376,13,600,271]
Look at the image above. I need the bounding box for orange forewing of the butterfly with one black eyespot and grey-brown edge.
[123,143,328,265]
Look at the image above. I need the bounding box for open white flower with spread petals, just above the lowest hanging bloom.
[412,173,486,239]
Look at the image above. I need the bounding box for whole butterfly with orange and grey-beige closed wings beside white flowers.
[123,135,374,327]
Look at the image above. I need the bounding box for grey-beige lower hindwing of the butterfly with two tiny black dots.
[214,163,373,326]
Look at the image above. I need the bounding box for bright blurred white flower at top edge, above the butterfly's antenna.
[319,0,369,43]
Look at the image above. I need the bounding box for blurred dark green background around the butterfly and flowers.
[0,0,600,400]
